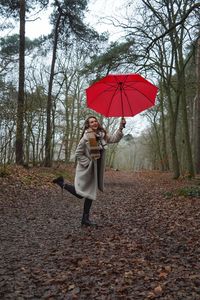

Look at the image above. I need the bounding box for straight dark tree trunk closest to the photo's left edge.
[15,0,26,165]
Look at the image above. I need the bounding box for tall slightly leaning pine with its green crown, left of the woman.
[45,0,99,166]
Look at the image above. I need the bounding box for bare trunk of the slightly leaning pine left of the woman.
[45,13,61,167]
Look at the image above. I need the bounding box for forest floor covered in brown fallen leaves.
[0,167,200,300]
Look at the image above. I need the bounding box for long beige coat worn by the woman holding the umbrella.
[74,129,123,200]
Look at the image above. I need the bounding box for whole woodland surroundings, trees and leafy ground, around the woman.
[0,0,200,300]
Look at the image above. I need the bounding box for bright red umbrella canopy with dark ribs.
[86,74,158,117]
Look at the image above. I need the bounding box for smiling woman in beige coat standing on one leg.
[53,116,126,226]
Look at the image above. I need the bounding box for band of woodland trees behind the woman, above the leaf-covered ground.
[0,0,200,178]
